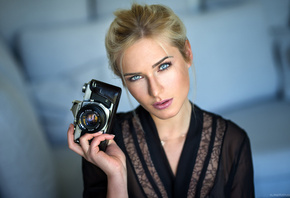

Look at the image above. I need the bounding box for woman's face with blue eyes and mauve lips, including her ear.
[122,38,192,119]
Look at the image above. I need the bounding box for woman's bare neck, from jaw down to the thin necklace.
[152,100,192,140]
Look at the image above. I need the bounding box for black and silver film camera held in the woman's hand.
[71,79,122,150]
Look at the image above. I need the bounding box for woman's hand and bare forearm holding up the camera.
[67,124,128,198]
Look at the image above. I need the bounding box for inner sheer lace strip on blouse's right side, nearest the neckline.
[187,114,212,198]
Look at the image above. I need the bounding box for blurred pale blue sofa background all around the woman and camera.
[0,0,290,198]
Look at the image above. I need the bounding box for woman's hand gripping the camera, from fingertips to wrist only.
[67,124,127,177]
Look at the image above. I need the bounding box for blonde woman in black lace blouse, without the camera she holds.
[68,4,254,198]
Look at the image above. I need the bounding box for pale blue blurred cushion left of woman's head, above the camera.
[19,20,110,81]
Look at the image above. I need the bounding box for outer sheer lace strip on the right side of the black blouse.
[200,118,226,197]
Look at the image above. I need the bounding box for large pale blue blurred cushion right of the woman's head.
[182,2,278,111]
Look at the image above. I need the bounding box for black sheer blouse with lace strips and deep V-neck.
[82,106,254,198]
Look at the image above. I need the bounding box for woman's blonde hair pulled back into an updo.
[105,4,190,79]
